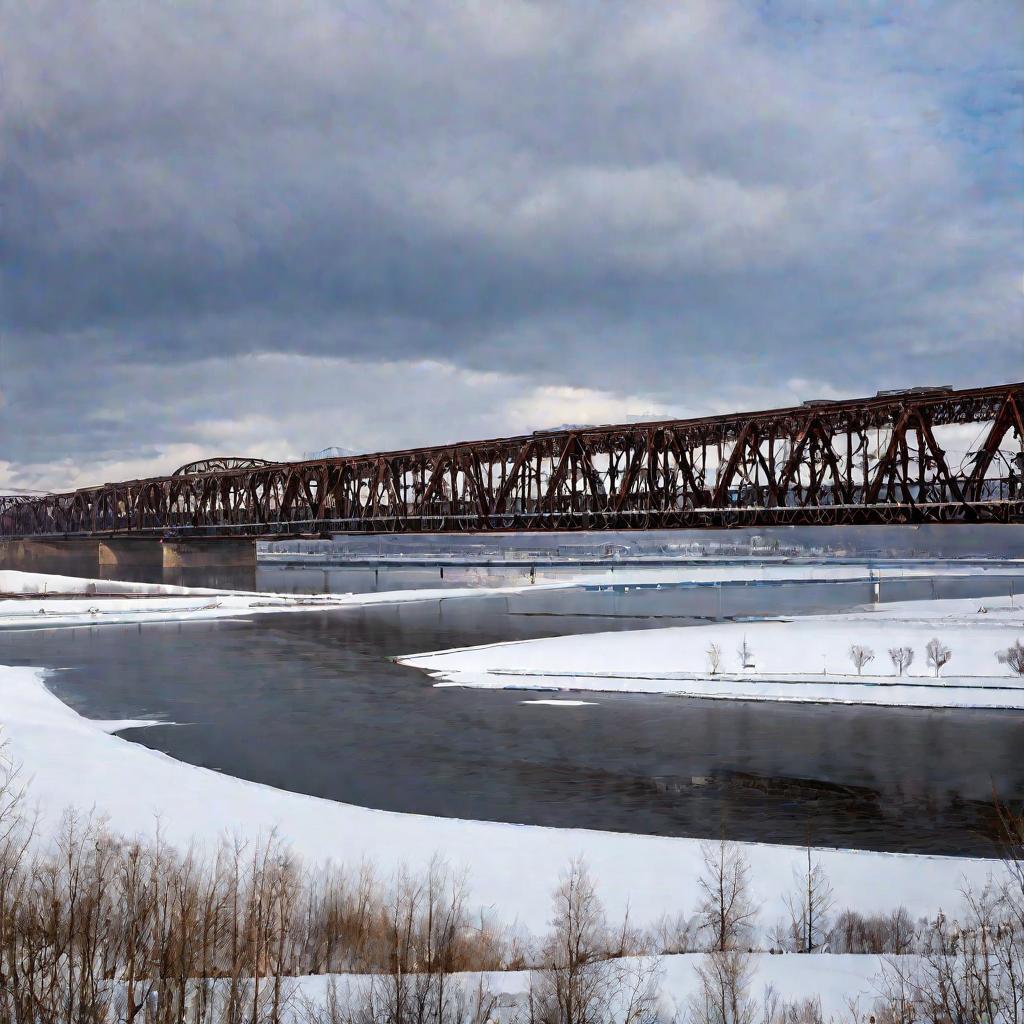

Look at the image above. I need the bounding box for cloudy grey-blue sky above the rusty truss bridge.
[0,0,1024,490]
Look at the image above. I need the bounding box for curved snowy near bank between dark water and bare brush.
[0,668,999,932]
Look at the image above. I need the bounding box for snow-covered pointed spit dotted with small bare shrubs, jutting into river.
[400,597,1024,709]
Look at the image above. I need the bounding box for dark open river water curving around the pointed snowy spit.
[0,570,1024,854]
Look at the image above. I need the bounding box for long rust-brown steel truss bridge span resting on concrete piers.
[0,383,1024,538]
